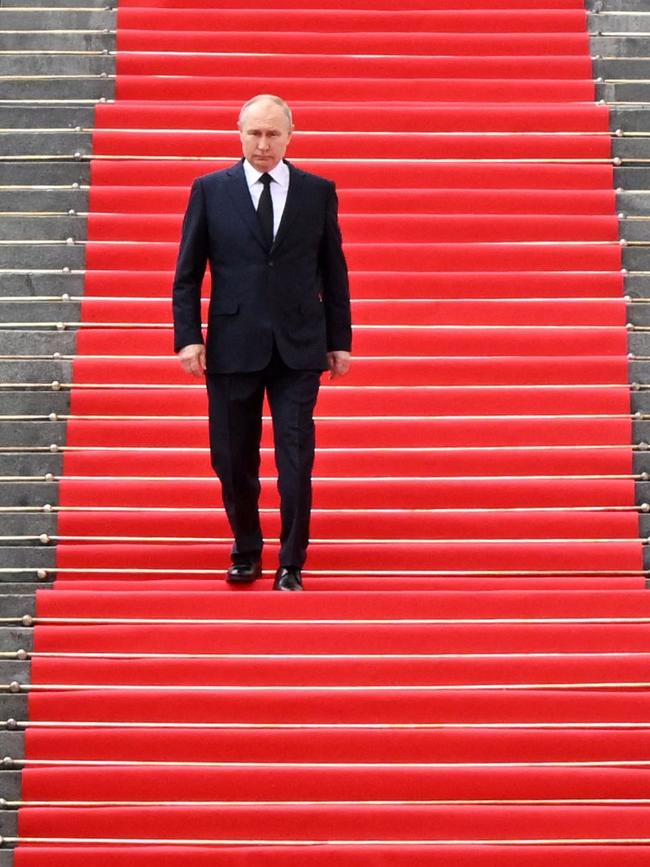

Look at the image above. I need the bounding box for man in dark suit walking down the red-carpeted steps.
[173,94,351,590]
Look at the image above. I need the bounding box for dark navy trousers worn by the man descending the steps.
[206,346,321,568]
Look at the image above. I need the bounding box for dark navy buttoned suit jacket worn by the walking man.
[173,159,351,373]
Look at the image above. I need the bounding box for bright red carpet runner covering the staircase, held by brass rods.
[16,0,650,867]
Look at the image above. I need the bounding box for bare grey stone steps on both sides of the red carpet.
[0,0,650,867]
